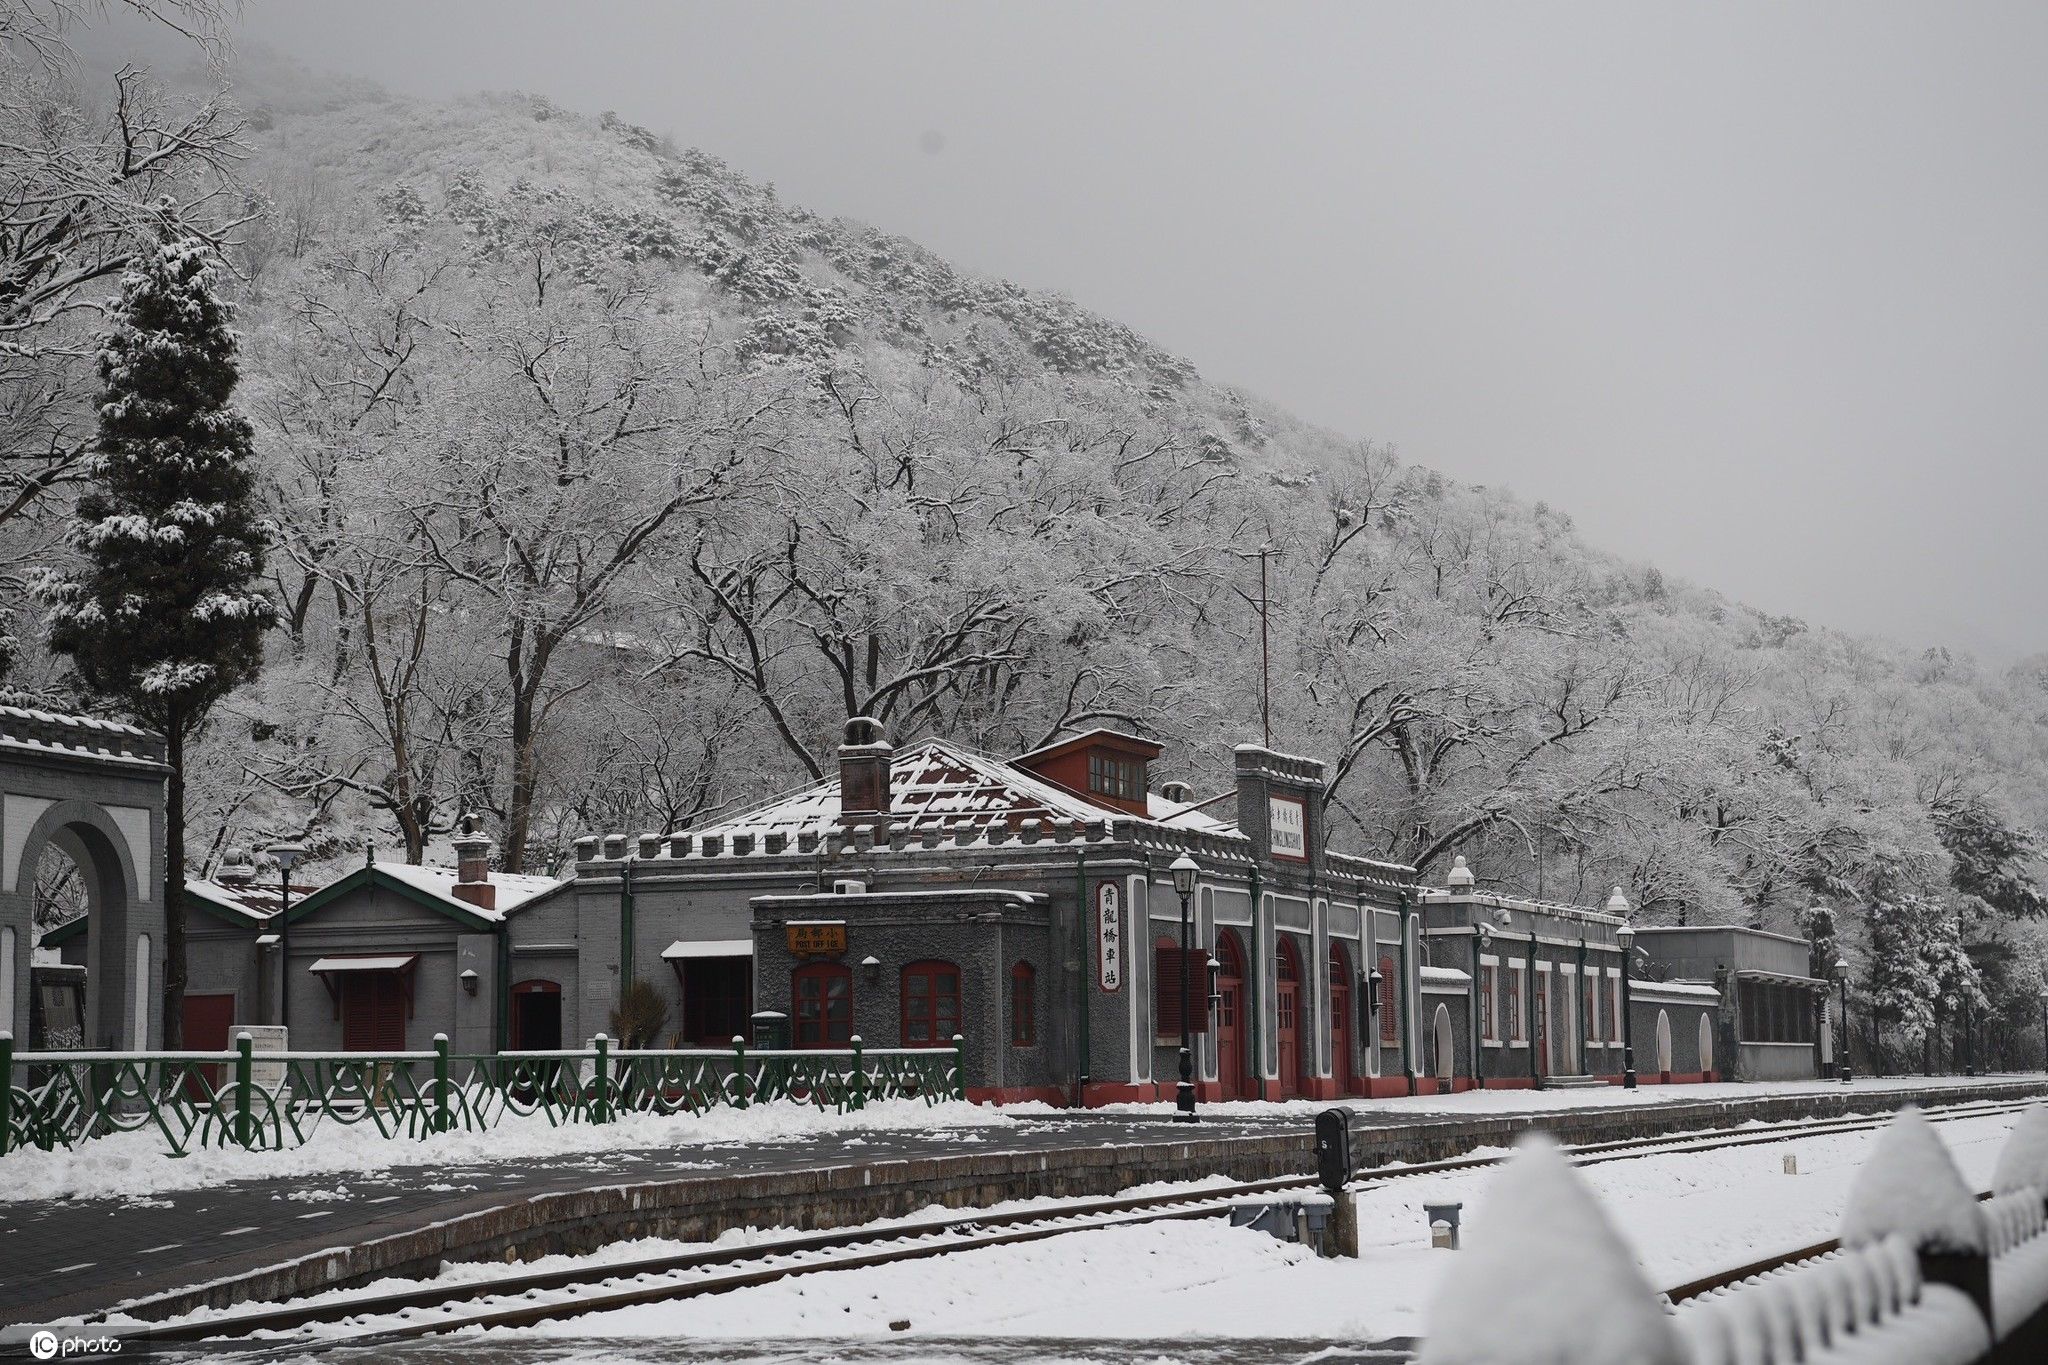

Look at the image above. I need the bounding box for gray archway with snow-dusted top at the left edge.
[0,706,166,1052]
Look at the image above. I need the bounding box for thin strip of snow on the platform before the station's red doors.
[1092,1072,2044,1117]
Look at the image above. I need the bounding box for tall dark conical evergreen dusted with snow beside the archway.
[39,233,276,1048]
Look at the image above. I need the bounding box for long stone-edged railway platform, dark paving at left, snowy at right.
[0,1074,2048,1324]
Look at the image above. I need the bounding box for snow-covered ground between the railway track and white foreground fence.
[495,1117,2013,1355]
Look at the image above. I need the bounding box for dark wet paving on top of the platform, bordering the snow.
[0,1113,1392,1322]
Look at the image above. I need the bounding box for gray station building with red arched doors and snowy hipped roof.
[575,720,1720,1105]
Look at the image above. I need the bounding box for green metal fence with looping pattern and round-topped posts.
[0,1033,967,1156]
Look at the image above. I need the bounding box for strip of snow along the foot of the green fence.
[0,1099,1016,1203]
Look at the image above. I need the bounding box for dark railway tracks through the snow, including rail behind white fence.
[99,1099,2038,1359]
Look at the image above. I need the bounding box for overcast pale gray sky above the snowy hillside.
[220,0,2048,661]
